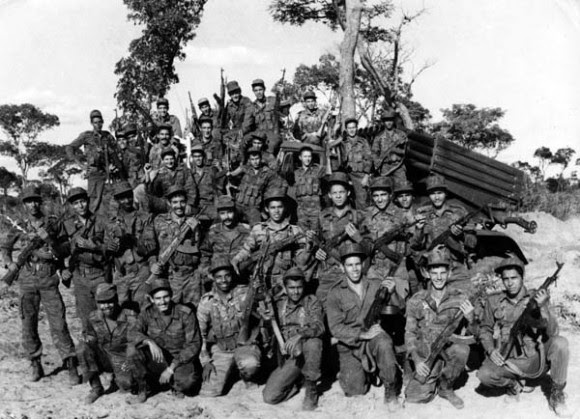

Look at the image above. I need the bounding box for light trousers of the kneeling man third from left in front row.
[199,345,261,397]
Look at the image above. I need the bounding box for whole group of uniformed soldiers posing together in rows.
[0,80,569,416]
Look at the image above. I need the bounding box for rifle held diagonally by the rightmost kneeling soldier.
[501,262,564,359]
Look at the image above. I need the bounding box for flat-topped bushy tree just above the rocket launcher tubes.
[431,104,514,158]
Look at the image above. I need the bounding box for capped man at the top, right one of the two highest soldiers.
[244,79,281,155]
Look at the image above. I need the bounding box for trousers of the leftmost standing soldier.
[20,284,75,360]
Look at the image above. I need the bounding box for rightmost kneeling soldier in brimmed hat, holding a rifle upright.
[477,256,572,417]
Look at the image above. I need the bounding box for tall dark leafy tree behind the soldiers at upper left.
[115,0,207,112]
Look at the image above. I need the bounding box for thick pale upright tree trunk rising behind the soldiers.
[339,0,362,122]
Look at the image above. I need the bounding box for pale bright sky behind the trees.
[0,0,580,179]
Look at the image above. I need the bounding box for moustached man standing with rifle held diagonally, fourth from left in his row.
[151,186,202,306]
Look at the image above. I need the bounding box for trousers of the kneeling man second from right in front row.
[405,343,469,403]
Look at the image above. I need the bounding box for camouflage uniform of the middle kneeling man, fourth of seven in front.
[263,295,325,404]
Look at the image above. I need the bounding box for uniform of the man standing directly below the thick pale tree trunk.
[344,136,373,210]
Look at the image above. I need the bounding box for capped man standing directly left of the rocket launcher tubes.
[372,110,407,176]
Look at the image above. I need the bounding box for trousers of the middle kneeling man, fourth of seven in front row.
[262,338,322,404]
